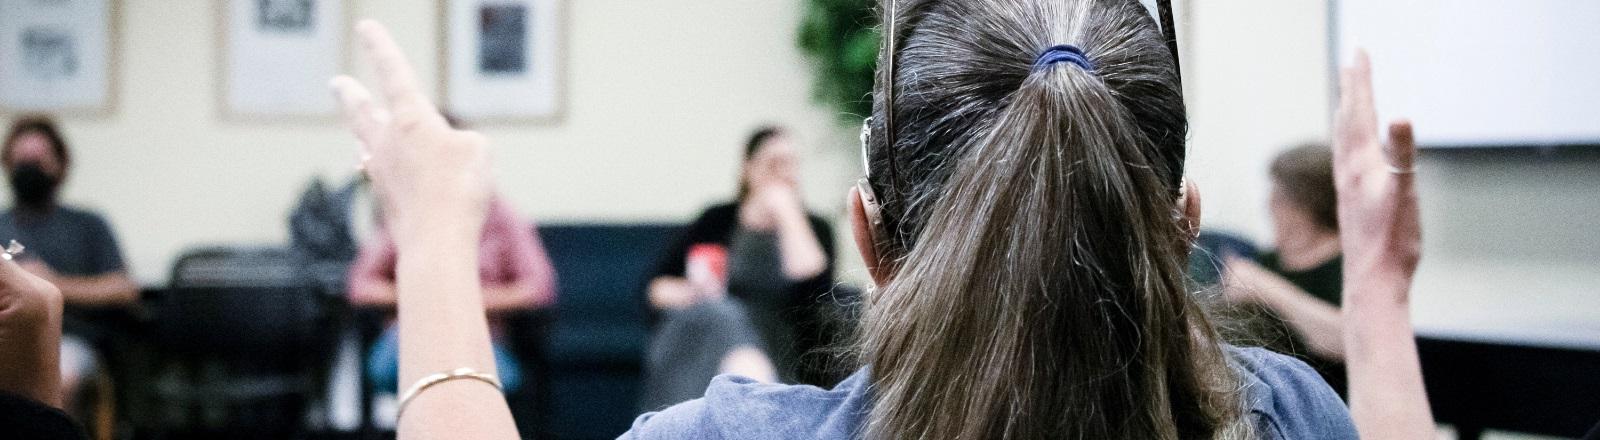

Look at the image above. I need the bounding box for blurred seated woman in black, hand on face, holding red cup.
[643,126,834,408]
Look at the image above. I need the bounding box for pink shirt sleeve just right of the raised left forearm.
[486,200,555,309]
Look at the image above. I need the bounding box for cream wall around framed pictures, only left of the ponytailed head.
[0,0,859,283]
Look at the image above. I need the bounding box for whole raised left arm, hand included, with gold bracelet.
[331,21,518,440]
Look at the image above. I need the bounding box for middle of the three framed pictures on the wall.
[218,0,349,118]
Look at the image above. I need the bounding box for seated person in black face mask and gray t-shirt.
[0,117,139,410]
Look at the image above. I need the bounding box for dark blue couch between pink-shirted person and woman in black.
[538,224,682,438]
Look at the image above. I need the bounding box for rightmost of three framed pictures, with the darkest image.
[440,0,565,123]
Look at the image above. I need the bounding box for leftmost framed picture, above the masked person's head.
[0,0,117,114]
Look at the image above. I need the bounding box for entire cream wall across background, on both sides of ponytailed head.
[3,0,1600,331]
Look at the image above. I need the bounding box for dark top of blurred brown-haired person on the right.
[1258,251,1347,397]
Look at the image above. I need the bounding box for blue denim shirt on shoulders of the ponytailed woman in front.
[618,347,1357,440]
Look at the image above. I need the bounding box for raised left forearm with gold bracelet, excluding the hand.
[397,226,517,440]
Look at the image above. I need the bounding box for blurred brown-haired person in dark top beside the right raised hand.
[1222,144,1346,397]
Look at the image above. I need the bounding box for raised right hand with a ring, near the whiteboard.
[1333,51,1422,304]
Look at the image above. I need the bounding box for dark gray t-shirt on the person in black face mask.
[0,206,123,277]
